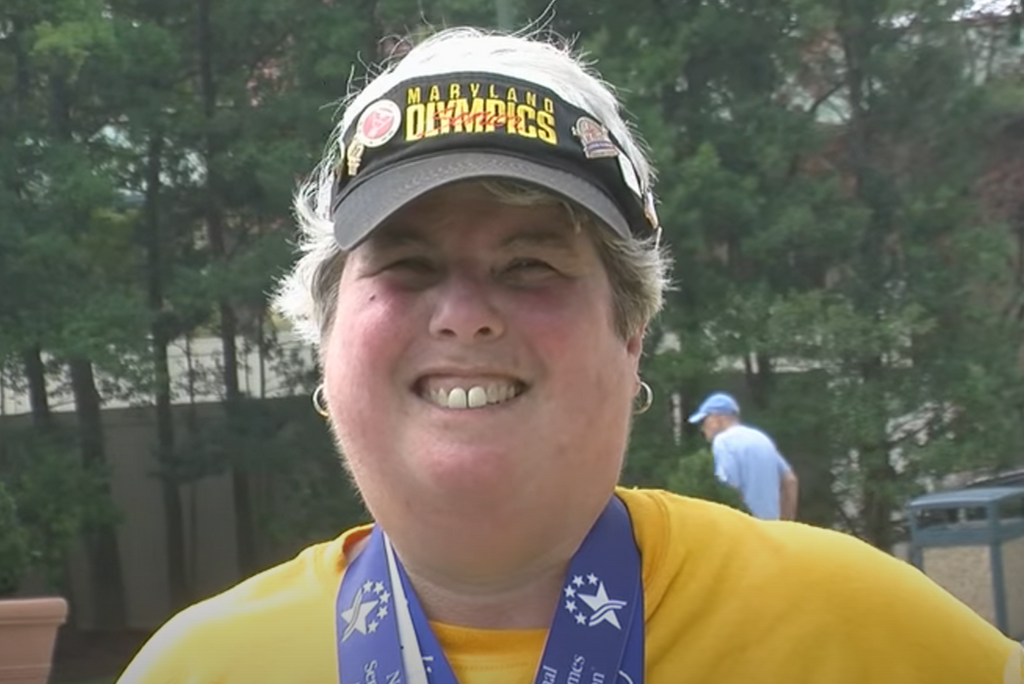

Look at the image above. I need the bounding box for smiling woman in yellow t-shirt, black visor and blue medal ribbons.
[120,29,1015,684]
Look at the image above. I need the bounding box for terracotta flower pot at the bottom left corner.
[0,597,68,684]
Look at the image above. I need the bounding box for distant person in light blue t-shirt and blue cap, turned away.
[689,392,800,520]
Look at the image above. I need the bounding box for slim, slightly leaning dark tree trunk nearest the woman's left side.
[198,0,257,575]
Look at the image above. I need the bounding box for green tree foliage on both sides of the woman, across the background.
[0,0,1024,589]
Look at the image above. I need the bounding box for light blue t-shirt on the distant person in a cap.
[711,425,790,520]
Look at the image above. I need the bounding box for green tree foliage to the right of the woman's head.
[577,0,1024,544]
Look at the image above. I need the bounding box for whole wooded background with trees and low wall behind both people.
[0,0,1024,681]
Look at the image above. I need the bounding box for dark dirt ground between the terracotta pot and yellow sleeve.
[50,626,150,684]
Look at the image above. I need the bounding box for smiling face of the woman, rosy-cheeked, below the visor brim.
[324,184,642,540]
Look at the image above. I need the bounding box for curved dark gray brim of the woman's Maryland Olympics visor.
[334,152,631,251]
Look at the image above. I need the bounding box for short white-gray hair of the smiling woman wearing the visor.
[272,28,669,346]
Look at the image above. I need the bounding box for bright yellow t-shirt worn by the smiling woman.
[118,489,1024,684]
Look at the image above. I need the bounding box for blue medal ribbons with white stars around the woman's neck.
[336,497,644,684]
